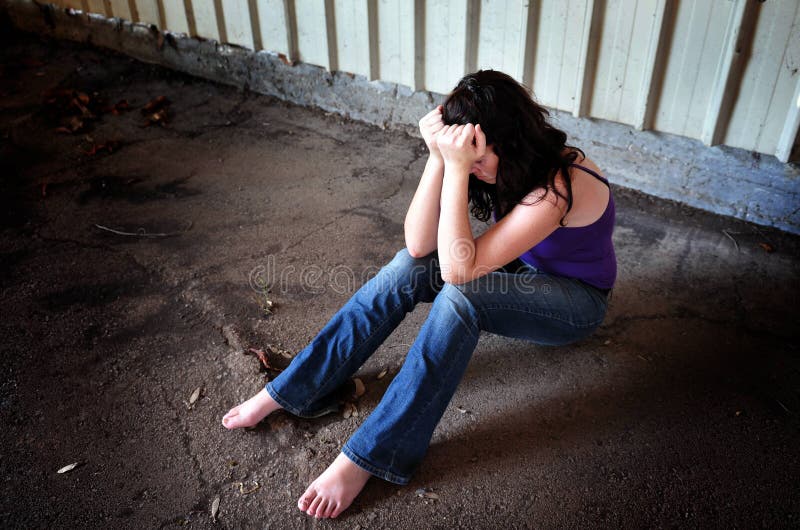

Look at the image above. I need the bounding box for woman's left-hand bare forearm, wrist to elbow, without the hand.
[404,155,444,257]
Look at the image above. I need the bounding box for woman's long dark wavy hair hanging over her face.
[442,70,585,226]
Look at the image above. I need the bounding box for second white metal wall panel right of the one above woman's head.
[590,0,660,124]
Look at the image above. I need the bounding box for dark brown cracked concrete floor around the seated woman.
[0,33,800,528]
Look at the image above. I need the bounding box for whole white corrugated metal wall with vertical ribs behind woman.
[54,0,800,161]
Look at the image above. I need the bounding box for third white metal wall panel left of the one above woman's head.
[333,0,370,78]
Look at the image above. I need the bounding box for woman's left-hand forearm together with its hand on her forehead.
[403,105,444,258]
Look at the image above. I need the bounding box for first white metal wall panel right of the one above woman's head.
[531,0,590,111]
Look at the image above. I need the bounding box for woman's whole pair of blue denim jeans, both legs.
[266,249,607,484]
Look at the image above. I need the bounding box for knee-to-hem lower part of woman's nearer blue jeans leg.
[342,284,480,484]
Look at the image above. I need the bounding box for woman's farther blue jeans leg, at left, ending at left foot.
[266,248,443,417]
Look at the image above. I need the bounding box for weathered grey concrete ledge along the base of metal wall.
[6,0,800,233]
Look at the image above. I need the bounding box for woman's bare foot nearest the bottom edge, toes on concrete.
[297,453,370,518]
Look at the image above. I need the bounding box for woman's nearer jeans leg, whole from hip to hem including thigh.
[342,270,606,484]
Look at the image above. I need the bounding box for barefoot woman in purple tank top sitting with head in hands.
[222,70,616,517]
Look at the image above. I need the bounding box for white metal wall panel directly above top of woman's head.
[477,0,530,81]
